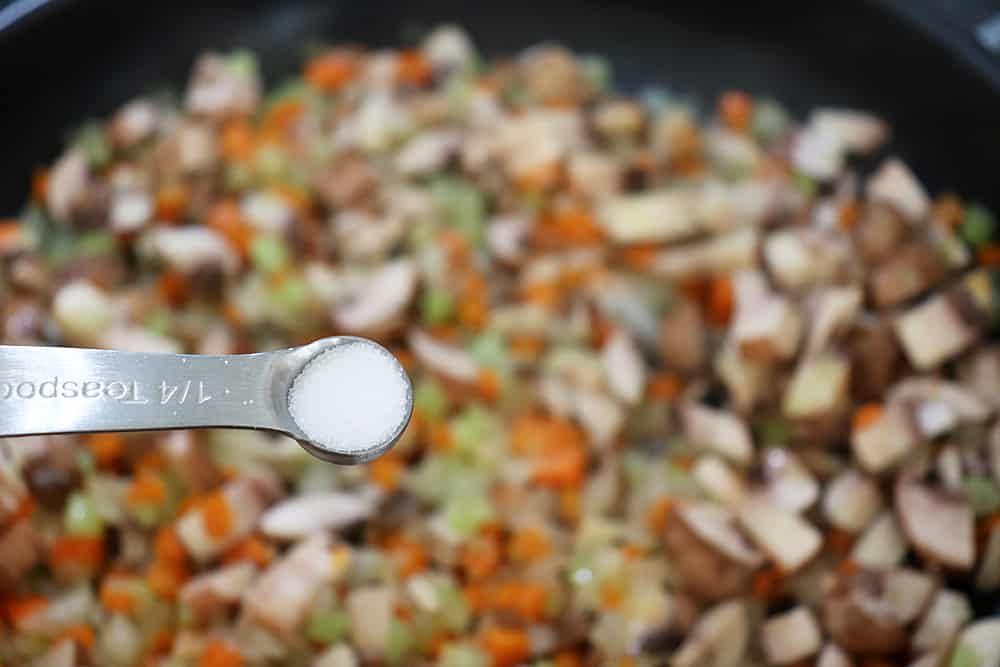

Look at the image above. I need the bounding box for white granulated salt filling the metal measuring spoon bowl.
[288,340,410,454]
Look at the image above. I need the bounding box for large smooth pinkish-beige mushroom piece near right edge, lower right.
[895,473,976,571]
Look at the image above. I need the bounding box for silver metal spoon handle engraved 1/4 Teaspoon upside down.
[0,345,281,437]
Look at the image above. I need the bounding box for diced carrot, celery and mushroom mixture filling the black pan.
[0,27,1000,667]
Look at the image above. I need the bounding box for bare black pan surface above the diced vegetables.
[0,0,1000,216]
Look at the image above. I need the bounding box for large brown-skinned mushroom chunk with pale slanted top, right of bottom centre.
[664,504,764,600]
